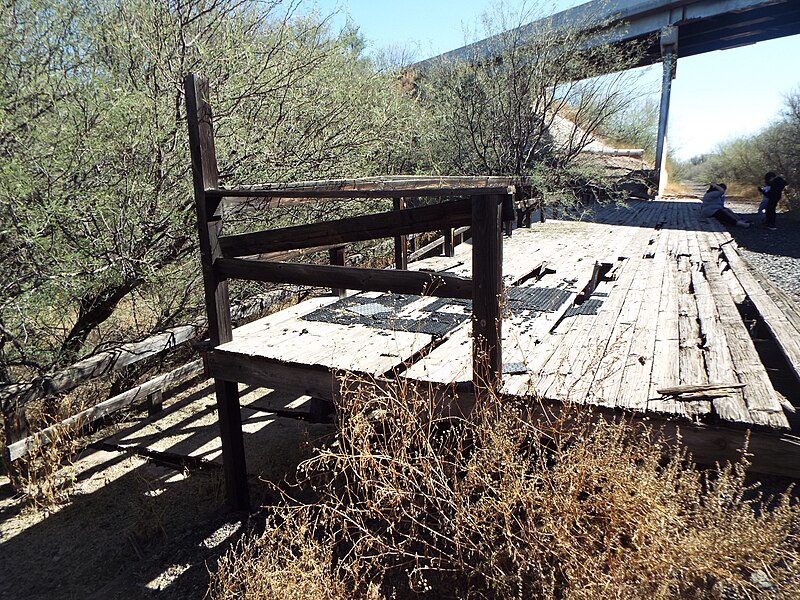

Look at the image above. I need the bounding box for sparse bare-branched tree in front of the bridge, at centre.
[422,4,634,195]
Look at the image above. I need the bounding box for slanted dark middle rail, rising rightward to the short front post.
[219,200,472,258]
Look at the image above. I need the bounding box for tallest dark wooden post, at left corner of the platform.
[184,73,250,509]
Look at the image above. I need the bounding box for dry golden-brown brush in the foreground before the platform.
[209,372,800,599]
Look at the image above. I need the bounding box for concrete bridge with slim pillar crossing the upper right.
[416,0,800,190]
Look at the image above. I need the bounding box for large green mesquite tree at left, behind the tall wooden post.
[0,0,422,381]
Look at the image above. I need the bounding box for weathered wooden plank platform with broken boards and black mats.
[209,199,800,430]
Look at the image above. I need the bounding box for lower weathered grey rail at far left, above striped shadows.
[6,360,204,462]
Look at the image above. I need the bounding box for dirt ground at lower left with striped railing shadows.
[0,382,332,600]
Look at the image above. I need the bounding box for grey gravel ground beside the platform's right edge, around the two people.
[716,199,800,303]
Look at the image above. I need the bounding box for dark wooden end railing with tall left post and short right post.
[184,74,519,508]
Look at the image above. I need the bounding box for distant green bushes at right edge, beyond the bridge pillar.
[673,89,800,202]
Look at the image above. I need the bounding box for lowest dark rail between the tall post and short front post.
[214,258,472,298]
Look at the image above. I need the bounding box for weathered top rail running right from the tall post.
[206,175,524,199]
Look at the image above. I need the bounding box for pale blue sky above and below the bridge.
[301,0,800,159]
